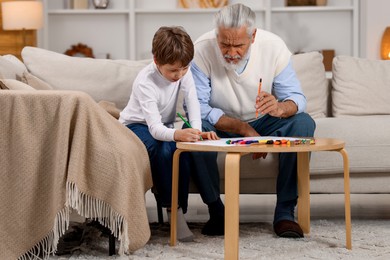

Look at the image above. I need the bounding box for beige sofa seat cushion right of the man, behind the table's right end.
[310,115,390,176]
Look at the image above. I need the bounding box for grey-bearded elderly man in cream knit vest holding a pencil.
[191,4,315,238]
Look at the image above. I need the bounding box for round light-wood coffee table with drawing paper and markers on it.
[170,137,352,259]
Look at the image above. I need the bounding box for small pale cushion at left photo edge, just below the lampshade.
[0,54,27,80]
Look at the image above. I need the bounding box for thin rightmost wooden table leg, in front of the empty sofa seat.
[339,149,352,250]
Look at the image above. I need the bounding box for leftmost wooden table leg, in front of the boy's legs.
[170,149,182,246]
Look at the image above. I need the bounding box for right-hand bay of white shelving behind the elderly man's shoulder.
[269,0,359,56]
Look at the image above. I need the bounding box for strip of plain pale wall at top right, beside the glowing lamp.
[360,0,390,59]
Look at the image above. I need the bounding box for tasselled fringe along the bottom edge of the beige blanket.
[18,182,129,260]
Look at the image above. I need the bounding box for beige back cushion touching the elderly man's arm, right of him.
[292,52,329,118]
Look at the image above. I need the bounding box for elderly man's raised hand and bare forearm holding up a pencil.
[255,91,298,118]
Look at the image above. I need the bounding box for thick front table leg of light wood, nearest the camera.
[225,153,241,259]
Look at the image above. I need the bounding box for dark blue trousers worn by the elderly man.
[191,113,315,203]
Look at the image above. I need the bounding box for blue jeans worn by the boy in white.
[127,124,190,213]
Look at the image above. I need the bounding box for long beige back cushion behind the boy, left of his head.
[22,47,151,110]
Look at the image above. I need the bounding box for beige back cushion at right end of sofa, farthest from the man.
[332,56,390,117]
